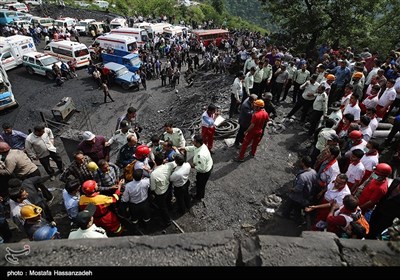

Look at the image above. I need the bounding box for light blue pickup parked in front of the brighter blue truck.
[103,62,140,90]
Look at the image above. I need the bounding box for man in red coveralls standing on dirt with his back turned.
[235,99,269,162]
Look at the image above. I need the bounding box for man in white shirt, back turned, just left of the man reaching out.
[169,154,192,214]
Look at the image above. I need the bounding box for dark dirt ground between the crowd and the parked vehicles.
[0,3,307,242]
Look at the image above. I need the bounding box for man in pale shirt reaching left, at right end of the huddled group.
[179,134,214,201]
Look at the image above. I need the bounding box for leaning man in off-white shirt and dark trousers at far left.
[25,125,63,181]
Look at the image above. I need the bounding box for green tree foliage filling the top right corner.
[259,0,400,58]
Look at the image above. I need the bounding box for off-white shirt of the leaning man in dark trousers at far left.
[25,127,57,158]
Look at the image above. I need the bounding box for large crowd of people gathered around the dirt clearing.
[0,17,400,242]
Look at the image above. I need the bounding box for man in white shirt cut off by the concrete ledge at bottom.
[68,203,108,239]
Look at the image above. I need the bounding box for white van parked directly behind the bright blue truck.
[95,34,138,52]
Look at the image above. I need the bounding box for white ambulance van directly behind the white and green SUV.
[44,40,90,67]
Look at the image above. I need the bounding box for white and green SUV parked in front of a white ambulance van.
[22,52,61,80]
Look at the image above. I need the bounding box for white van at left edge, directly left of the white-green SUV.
[0,35,36,70]
